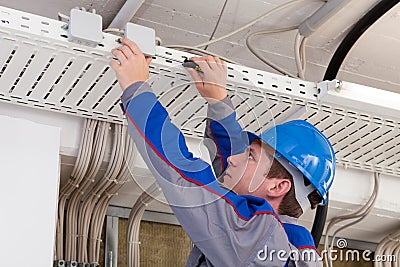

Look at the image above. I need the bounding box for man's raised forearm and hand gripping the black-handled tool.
[188,56,247,177]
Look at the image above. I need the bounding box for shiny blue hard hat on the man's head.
[246,120,336,204]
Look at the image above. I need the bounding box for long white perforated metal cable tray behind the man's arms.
[0,7,400,176]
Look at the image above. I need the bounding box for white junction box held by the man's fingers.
[125,22,156,56]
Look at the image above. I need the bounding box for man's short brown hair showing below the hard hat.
[267,158,322,218]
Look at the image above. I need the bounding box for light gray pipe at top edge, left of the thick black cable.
[299,0,351,37]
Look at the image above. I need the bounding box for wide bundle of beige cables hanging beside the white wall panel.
[55,122,136,264]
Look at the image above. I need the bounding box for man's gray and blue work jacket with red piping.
[122,82,322,267]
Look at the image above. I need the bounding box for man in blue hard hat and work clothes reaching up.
[110,38,335,266]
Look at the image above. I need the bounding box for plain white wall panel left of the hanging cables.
[0,115,61,267]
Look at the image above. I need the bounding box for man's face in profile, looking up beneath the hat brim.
[223,139,274,198]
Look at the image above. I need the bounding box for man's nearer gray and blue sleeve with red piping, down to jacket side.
[122,82,290,266]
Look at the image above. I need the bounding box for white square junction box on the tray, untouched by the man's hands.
[68,9,103,47]
